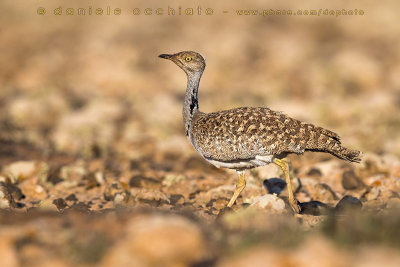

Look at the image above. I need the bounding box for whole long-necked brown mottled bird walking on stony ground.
[159,51,362,213]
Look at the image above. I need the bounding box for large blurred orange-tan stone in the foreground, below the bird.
[102,215,206,267]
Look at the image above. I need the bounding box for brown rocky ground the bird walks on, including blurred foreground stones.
[0,140,400,266]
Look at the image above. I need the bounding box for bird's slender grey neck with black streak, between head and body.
[183,72,203,135]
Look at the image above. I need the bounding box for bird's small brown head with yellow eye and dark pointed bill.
[158,51,206,75]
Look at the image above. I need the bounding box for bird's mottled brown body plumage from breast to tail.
[189,107,359,161]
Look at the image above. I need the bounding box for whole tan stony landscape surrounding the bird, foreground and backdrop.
[0,0,400,266]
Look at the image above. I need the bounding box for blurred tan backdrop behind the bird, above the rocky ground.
[0,0,400,159]
